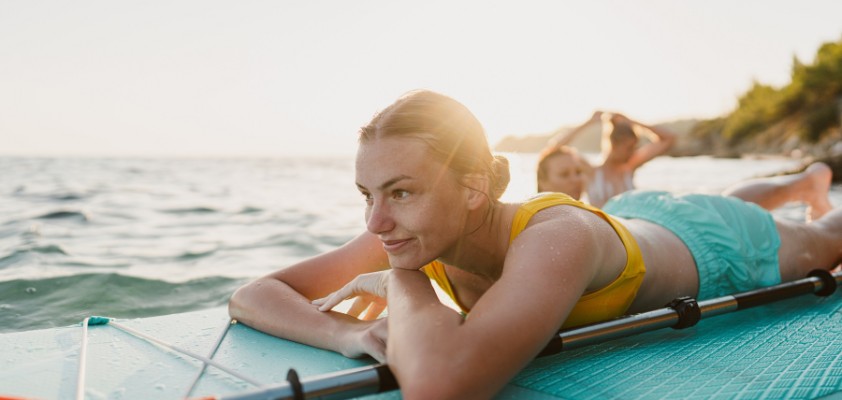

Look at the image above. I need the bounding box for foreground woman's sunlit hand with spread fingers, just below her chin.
[312,270,391,321]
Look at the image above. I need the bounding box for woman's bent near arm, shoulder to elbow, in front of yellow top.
[387,211,600,399]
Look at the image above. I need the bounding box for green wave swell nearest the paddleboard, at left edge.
[0,273,245,332]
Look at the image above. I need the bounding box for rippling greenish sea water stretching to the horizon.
[0,154,842,332]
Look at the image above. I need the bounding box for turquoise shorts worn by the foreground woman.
[603,191,781,300]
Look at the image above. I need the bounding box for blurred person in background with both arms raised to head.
[547,111,675,207]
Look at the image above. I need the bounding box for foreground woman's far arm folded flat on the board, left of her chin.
[228,232,389,361]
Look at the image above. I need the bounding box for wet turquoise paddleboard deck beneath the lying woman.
[0,291,842,399]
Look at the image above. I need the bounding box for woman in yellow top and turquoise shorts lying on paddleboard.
[229,91,842,399]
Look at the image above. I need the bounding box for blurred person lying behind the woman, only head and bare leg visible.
[537,129,833,221]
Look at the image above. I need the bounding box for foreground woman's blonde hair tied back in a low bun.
[359,90,509,201]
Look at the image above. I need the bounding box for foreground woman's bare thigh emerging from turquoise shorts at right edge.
[775,208,842,282]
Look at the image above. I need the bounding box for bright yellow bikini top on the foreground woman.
[421,193,646,328]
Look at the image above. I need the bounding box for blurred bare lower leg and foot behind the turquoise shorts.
[722,162,833,221]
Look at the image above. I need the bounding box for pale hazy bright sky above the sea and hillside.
[0,0,842,157]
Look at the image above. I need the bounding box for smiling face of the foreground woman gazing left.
[356,138,468,269]
